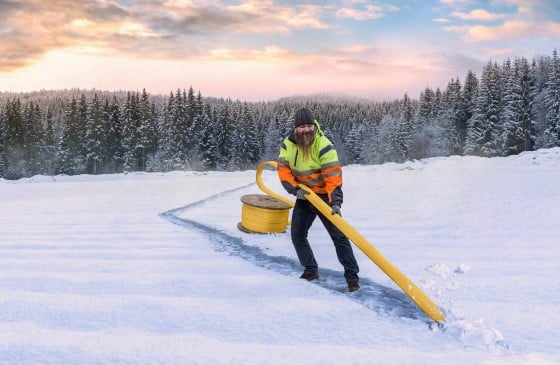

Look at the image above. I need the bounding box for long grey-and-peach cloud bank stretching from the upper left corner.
[0,0,329,72]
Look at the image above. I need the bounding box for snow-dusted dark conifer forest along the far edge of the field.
[0,50,560,179]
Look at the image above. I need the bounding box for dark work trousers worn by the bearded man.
[291,194,359,281]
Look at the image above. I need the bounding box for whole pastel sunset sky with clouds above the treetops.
[0,0,560,101]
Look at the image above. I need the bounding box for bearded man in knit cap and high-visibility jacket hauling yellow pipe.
[277,108,360,292]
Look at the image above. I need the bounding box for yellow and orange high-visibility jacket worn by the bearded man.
[277,120,343,206]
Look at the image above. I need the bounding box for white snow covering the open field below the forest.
[0,148,560,365]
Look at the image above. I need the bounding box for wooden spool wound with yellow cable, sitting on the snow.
[237,194,291,233]
